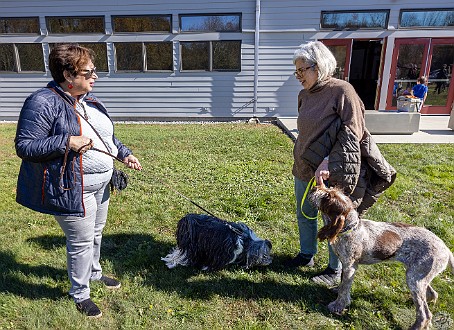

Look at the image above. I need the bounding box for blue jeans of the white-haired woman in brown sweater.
[295,177,341,269]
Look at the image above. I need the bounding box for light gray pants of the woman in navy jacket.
[55,182,110,303]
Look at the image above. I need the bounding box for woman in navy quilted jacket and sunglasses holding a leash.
[15,44,142,317]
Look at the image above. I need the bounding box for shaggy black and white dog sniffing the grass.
[161,214,272,271]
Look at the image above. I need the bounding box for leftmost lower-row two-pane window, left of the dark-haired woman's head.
[0,44,45,72]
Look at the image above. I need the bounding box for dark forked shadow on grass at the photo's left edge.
[0,251,66,300]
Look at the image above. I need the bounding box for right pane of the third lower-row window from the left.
[145,42,173,71]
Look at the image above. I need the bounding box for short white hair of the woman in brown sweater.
[293,41,337,81]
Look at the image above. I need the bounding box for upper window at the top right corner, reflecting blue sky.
[399,8,454,28]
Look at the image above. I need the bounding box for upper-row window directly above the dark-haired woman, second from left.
[46,16,105,34]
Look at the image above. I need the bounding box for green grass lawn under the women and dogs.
[0,123,454,330]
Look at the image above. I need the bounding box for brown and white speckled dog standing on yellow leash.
[310,186,454,329]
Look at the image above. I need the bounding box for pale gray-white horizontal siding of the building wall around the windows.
[0,0,452,119]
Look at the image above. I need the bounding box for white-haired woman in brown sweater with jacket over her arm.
[285,41,396,287]
